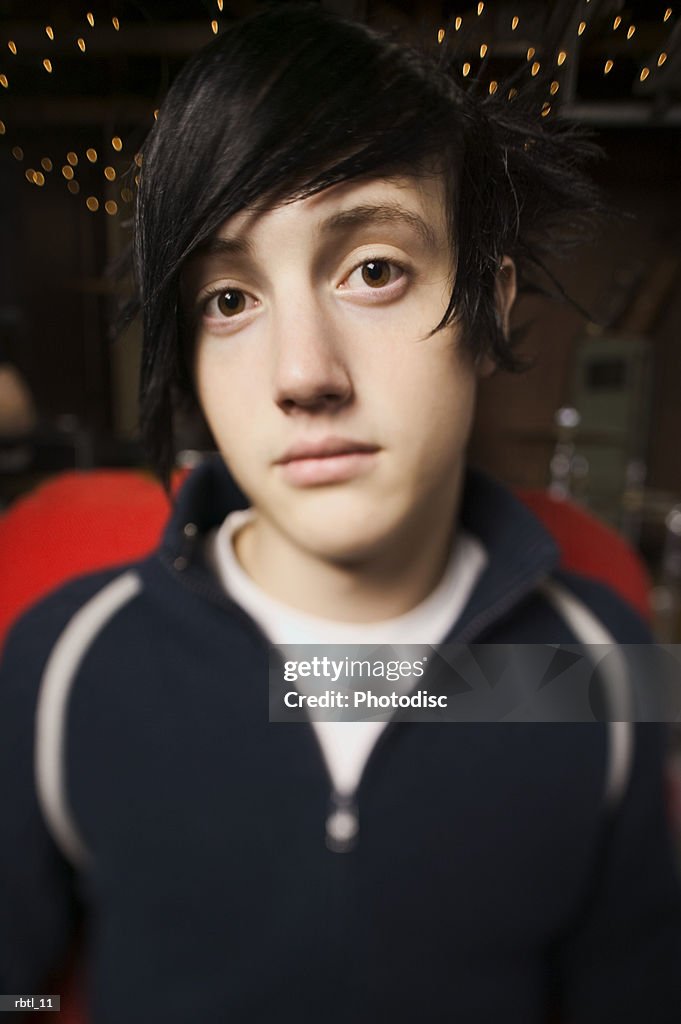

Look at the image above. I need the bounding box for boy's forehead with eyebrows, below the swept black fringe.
[205,174,448,247]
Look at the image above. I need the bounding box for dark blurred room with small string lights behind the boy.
[0,0,681,641]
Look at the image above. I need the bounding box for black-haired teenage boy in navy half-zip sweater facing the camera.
[0,5,681,1024]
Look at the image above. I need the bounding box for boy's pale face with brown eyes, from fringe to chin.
[183,177,491,564]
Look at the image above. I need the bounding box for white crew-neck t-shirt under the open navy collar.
[206,509,487,796]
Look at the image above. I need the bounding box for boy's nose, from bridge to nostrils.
[271,301,353,414]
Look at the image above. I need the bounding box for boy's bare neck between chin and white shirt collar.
[235,487,458,623]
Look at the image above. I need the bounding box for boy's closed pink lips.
[275,437,380,487]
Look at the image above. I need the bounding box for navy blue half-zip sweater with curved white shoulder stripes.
[0,462,681,1024]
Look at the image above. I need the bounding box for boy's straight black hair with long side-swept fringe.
[134,4,595,480]
